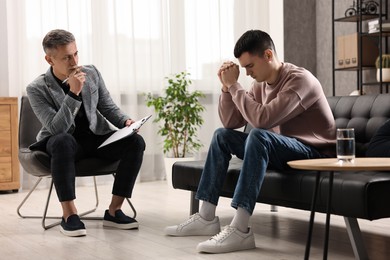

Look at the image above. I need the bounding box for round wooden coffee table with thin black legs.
[288,157,390,259]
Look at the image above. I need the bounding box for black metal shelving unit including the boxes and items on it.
[332,0,390,95]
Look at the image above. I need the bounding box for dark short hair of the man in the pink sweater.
[234,30,276,58]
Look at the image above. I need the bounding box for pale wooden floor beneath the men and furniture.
[0,182,390,260]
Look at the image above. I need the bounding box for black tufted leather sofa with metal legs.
[172,94,390,259]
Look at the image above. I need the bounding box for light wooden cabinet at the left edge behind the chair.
[0,97,20,191]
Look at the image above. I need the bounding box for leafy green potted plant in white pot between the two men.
[146,71,205,183]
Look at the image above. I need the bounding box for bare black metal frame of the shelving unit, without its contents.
[332,0,390,95]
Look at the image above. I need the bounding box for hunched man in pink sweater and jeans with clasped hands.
[165,30,335,253]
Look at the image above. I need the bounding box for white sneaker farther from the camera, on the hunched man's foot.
[165,213,221,237]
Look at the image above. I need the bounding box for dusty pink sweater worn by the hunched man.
[218,63,336,155]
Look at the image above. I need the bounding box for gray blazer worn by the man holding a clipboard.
[27,65,130,141]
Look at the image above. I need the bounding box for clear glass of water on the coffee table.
[336,128,355,162]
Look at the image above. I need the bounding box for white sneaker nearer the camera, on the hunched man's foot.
[196,226,256,253]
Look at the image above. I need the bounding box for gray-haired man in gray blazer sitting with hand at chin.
[27,30,145,236]
